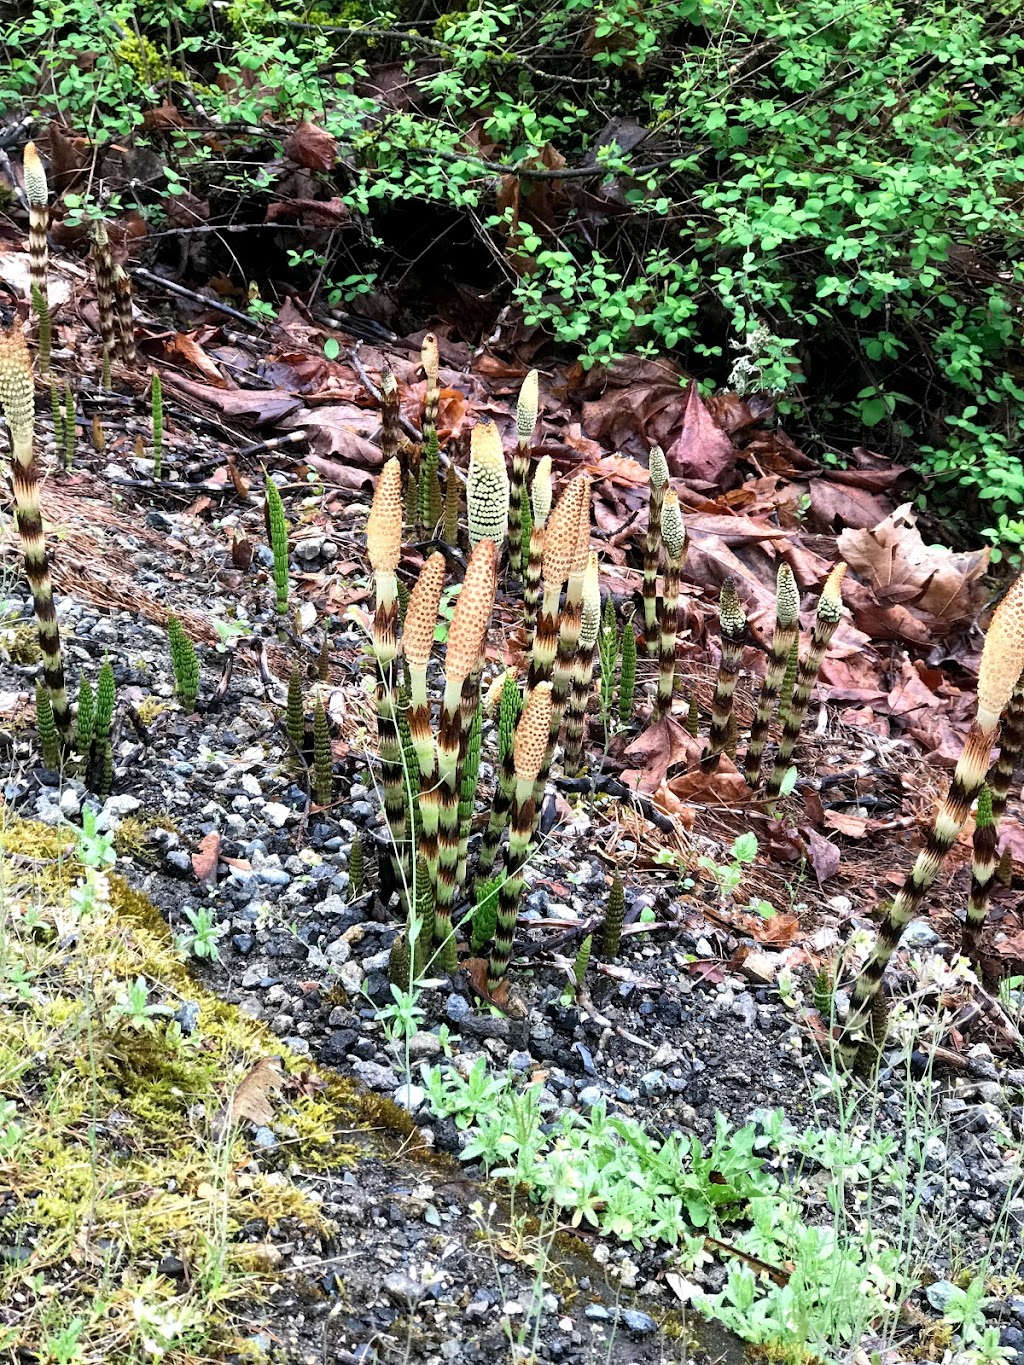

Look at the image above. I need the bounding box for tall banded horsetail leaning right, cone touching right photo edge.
[840,576,1024,1065]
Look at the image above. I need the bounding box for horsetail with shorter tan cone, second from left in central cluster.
[401,553,445,887]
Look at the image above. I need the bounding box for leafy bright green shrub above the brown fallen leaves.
[0,0,1024,550]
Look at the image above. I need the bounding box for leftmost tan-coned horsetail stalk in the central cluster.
[366,456,412,886]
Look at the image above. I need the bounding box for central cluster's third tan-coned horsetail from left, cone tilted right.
[434,541,497,972]
